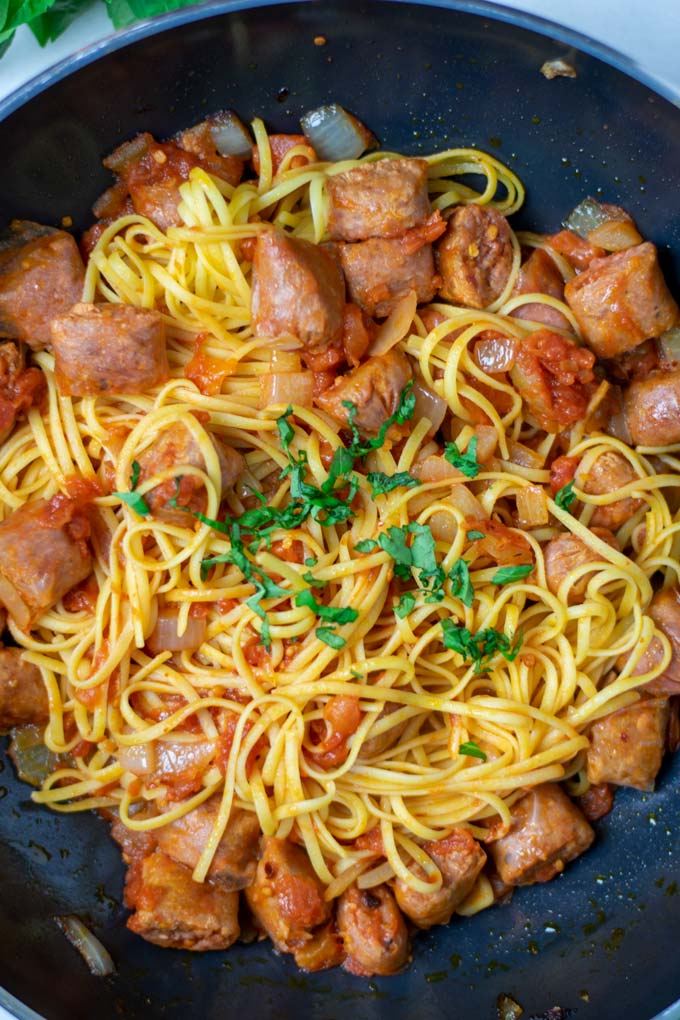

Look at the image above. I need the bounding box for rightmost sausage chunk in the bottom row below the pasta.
[489,782,595,885]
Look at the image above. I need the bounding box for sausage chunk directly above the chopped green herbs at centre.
[316,349,411,434]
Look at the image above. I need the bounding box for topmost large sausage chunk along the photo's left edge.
[0,221,85,351]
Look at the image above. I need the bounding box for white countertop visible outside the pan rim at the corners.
[0,0,680,1020]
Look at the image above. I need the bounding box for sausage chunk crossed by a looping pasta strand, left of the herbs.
[139,423,246,527]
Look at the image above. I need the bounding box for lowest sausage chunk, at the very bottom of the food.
[337,885,409,977]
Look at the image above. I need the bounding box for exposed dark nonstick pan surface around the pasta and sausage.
[0,0,680,1020]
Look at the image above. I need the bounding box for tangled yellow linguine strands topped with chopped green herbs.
[0,107,680,965]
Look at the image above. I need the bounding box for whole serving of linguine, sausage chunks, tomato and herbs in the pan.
[0,107,680,975]
